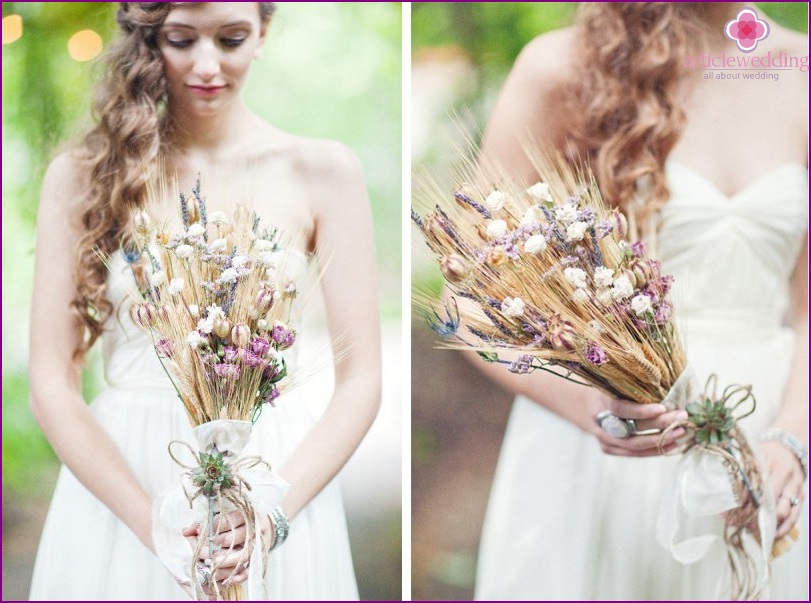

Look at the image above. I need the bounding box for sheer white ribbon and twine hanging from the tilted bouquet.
[656,367,777,600]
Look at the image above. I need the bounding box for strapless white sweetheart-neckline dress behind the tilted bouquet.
[476,163,808,601]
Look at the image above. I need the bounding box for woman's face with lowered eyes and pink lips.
[158,2,265,116]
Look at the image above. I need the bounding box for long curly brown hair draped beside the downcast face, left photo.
[71,2,276,358]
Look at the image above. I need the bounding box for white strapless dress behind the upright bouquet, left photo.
[31,252,358,601]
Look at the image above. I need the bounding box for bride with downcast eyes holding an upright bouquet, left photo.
[30,2,380,600]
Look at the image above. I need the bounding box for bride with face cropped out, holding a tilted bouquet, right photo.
[474,3,808,600]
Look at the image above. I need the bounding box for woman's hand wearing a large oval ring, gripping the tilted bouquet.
[592,396,687,456]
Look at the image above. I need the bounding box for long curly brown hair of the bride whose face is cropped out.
[570,2,706,232]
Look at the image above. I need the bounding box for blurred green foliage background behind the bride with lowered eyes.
[2,2,402,599]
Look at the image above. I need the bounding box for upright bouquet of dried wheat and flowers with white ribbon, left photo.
[125,182,297,600]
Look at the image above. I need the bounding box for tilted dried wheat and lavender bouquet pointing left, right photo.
[412,159,788,598]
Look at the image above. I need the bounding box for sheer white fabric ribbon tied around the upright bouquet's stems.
[152,420,289,601]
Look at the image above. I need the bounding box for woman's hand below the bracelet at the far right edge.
[761,442,805,540]
